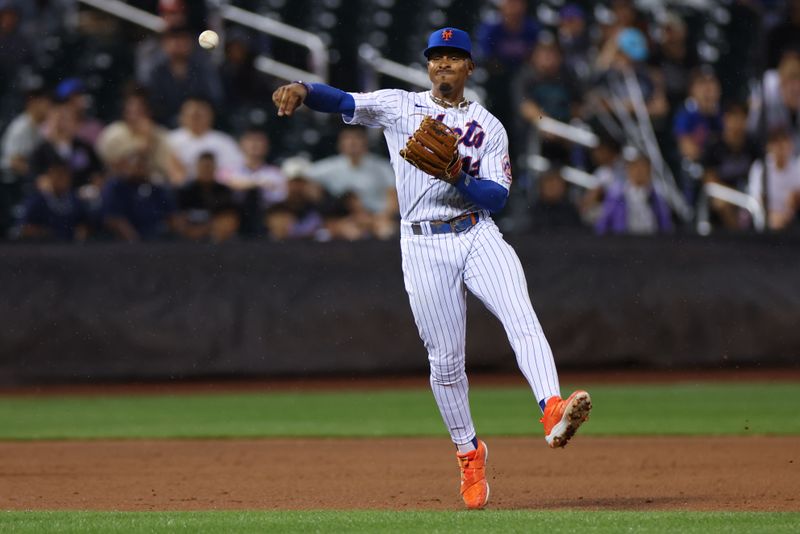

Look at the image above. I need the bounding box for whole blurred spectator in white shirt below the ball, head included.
[169,97,244,176]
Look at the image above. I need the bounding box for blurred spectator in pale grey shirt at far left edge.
[1,89,51,180]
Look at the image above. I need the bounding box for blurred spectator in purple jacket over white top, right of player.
[595,149,673,235]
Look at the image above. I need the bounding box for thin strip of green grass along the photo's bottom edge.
[0,511,800,534]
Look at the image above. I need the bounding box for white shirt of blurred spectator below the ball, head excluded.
[169,128,244,177]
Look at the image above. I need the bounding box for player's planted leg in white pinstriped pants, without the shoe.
[401,235,475,446]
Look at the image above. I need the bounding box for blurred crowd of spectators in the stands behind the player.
[0,0,800,242]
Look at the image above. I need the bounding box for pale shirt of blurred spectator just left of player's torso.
[309,154,395,213]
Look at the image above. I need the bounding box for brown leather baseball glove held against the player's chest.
[400,116,461,184]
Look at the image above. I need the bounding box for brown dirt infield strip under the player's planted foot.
[0,437,800,511]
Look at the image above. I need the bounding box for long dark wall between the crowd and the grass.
[0,236,800,384]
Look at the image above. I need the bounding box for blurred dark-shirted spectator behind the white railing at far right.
[703,102,760,230]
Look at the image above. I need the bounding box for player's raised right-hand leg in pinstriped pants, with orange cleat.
[464,221,591,447]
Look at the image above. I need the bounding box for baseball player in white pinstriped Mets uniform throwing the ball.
[272,28,592,509]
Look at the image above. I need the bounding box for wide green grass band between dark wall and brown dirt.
[0,383,800,439]
